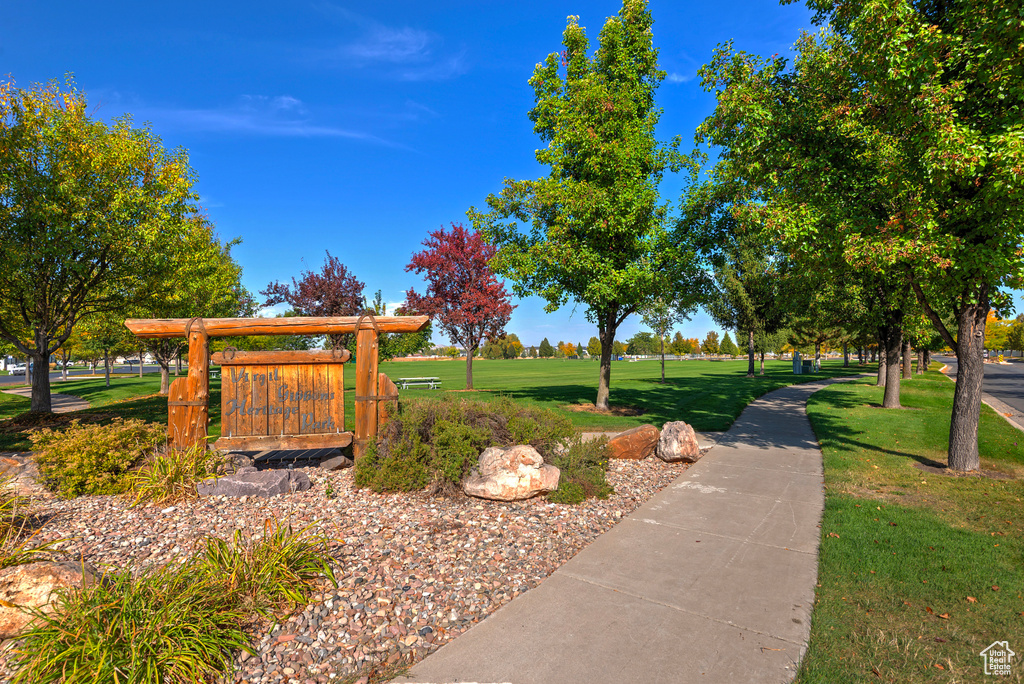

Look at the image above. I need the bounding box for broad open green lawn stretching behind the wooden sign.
[0,358,862,450]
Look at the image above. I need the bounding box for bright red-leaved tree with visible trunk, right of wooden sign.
[406,223,515,389]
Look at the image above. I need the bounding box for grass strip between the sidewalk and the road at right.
[797,372,1024,684]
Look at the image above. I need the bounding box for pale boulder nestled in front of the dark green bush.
[462,444,561,501]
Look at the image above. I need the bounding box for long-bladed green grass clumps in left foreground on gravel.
[11,525,337,684]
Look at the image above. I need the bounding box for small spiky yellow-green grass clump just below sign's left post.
[127,444,222,504]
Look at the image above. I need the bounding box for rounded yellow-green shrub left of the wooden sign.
[31,418,167,498]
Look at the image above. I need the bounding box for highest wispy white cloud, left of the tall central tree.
[308,2,468,81]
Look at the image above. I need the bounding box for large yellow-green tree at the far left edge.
[0,81,195,412]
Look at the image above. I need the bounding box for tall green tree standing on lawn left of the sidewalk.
[469,0,699,410]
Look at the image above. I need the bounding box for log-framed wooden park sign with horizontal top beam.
[125,313,428,458]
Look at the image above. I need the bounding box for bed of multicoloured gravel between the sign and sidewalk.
[0,458,687,684]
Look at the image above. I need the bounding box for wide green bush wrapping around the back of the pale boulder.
[355,395,611,503]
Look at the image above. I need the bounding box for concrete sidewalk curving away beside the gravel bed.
[395,381,851,684]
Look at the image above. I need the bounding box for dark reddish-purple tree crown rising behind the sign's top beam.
[260,252,366,347]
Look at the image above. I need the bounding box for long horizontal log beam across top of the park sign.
[125,315,430,339]
